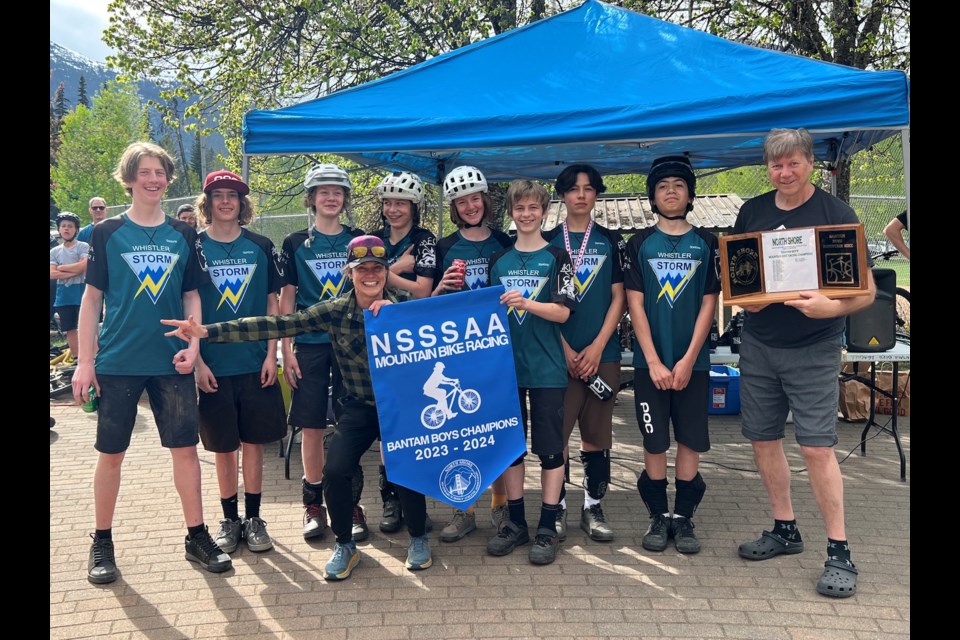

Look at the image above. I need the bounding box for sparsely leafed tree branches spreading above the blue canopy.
[104,0,910,205]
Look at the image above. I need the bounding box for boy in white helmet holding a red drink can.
[433,166,513,542]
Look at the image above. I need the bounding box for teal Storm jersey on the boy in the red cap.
[199,228,283,376]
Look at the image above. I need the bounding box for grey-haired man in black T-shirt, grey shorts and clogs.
[733,129,876,598]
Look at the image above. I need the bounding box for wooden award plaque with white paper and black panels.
[720,224,869,307]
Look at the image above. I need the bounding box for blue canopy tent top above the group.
[244,0,910,183]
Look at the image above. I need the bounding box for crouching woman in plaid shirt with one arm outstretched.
[161,236,433,580]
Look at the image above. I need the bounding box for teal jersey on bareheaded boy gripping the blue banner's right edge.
[490,245,577,389]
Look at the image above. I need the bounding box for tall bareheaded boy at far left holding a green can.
[73,142,233,584]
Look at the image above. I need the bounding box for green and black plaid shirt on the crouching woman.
[206,289,412,406]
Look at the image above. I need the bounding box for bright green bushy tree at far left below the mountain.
[50,82,150,219]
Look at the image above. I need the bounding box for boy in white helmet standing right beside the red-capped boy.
[280,164,369,540]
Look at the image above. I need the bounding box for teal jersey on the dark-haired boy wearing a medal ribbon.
[543,223,628,362]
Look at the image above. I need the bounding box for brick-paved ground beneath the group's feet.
[50,391,910,640]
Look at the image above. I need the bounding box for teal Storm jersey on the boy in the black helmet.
[625,227,720,371]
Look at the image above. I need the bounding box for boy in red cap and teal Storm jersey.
[192,171,287,553]
